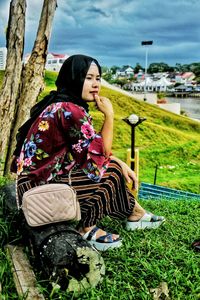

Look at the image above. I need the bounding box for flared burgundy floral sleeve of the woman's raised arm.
[61,106,110,182]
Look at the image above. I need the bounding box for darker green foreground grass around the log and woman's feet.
[0,196,200,300]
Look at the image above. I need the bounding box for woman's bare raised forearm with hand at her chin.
[94,94,114,156]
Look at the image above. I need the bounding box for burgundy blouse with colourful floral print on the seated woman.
[17,102,110,182]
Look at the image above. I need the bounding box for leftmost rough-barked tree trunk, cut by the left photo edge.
[0,0,26,175]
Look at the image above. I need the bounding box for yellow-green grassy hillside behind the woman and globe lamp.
[0,71,200,193]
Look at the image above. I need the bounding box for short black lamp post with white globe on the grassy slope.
[123,114,146,175]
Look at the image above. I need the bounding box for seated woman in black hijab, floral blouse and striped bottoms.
[14,55,164,250]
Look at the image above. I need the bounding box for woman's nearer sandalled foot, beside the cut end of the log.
[79,226,122,251]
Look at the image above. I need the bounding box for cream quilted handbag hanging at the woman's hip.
[17,170,81,227]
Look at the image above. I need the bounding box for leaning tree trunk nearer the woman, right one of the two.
[4,0,57,174]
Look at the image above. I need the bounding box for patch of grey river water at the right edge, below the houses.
[165,97,200,121]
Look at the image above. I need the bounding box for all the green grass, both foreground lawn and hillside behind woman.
[0,72,200,300]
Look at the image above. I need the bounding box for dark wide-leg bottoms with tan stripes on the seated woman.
[17,160,135,227]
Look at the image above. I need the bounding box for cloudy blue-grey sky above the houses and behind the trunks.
[0,0,200,67]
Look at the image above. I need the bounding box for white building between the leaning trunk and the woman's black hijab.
[45,53,69,72]
